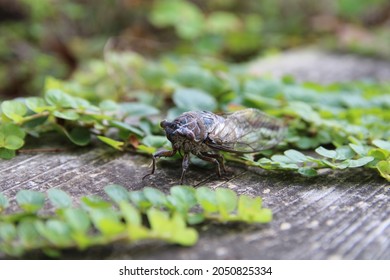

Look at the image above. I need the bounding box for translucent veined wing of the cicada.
[206,109,286,153]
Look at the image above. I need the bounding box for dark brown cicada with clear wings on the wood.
[144,108,286,184]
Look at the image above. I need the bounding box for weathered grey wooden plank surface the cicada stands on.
[0,48,390,259]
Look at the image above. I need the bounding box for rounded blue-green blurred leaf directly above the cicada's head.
[173,88,218,111]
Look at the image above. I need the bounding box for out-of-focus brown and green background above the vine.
[0,0,390,99]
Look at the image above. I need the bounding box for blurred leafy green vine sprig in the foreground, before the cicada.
[0,185,272,257]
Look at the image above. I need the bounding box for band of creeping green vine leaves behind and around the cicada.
[0,48,390,180]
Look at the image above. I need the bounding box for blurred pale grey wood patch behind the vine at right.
[250,48,390,84]
